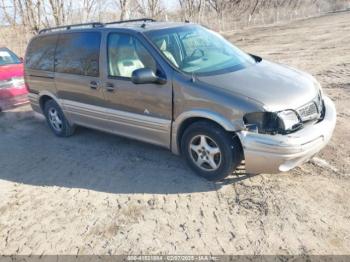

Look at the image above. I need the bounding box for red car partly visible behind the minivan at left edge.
[0,47,28,112]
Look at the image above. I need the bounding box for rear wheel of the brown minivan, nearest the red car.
[44,99,75,137]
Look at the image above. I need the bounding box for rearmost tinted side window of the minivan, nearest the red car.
[26,35,57,72]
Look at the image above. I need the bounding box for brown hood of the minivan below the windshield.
[198,60,318,112]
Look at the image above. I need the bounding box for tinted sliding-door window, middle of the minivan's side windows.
[55,32,101,77]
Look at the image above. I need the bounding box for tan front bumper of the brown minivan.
[238,96,336,174]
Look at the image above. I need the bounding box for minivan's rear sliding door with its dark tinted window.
[55,30,107,129]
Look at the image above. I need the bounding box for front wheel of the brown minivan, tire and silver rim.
[181,121,243,181]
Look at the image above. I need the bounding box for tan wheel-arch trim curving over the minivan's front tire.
[171,109,244,155]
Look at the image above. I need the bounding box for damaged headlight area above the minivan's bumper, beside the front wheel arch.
[243,110,302,134]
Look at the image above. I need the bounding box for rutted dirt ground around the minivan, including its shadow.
[0,12,350,254]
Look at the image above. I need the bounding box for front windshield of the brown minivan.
[148,26,255,74]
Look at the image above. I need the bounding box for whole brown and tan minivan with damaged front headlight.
[25,19,336,181]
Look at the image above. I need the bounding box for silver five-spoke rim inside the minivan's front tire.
[189,135,221,171]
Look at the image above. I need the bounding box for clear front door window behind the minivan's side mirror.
[107,33,157,78]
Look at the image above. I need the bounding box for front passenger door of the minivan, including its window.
[103,32,172,147]
